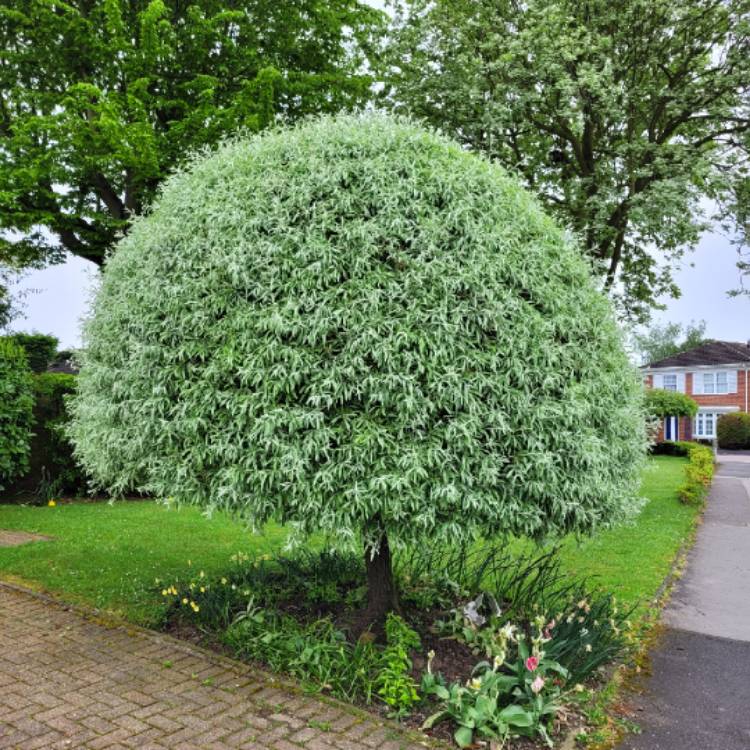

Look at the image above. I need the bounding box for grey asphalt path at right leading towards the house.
[619,455,750,750]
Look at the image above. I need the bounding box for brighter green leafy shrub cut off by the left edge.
[0,339,34,490]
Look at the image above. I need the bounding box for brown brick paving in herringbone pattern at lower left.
[0,584,434,750]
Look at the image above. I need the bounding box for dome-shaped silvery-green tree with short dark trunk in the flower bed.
[72,116,645,619]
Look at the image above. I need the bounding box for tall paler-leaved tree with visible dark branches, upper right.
[384,0,750,319]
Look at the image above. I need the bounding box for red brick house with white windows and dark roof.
[641,341,750,440]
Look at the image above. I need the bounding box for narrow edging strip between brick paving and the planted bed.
[0,579,452,750]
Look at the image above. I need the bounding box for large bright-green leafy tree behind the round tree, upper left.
[0,0,382,267]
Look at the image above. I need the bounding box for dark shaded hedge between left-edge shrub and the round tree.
[3,372,86,502]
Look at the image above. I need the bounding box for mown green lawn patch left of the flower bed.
[0,501,294,625]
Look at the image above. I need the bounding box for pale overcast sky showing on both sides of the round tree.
[7,223,750,348]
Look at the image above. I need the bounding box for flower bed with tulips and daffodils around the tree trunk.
[159,544,630,747]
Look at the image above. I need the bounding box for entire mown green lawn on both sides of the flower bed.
[0,456,698,625]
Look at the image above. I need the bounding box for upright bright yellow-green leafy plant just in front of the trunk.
[377,612,421,716]
